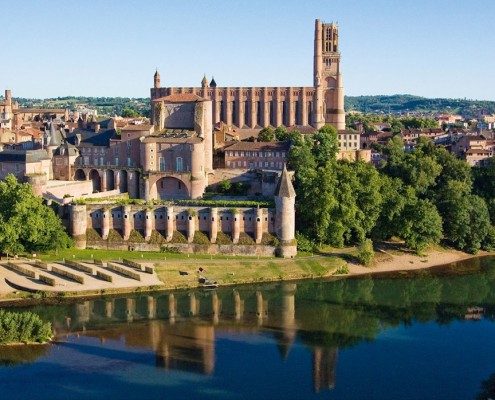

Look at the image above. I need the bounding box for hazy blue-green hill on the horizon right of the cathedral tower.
[345,94,495,118]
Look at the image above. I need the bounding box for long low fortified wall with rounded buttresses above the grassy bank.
[70,204,296,257]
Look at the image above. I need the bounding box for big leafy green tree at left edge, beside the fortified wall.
[0,175,71,254]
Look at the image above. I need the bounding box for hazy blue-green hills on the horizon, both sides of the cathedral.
[6,94,495,118]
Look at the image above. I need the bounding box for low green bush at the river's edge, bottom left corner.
[0,309,53,344]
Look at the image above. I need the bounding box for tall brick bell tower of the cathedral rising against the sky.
[313,19,345,130]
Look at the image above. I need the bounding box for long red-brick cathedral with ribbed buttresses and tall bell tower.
[151,20,345,130]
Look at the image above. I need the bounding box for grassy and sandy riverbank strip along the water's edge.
[0,245,495,305]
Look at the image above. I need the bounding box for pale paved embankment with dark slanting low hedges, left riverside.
[0,260,162,292]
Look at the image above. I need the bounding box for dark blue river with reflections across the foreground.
[0,258,495,400]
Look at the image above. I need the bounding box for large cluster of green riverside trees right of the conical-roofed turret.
[289,126,495,253]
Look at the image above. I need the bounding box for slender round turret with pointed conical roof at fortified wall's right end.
[275,165,297,257]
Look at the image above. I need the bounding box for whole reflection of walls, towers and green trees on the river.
[5,255,495,393]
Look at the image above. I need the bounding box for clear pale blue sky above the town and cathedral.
[0,0,495,100]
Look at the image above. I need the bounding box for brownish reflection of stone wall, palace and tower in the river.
[59,283,338,392]
